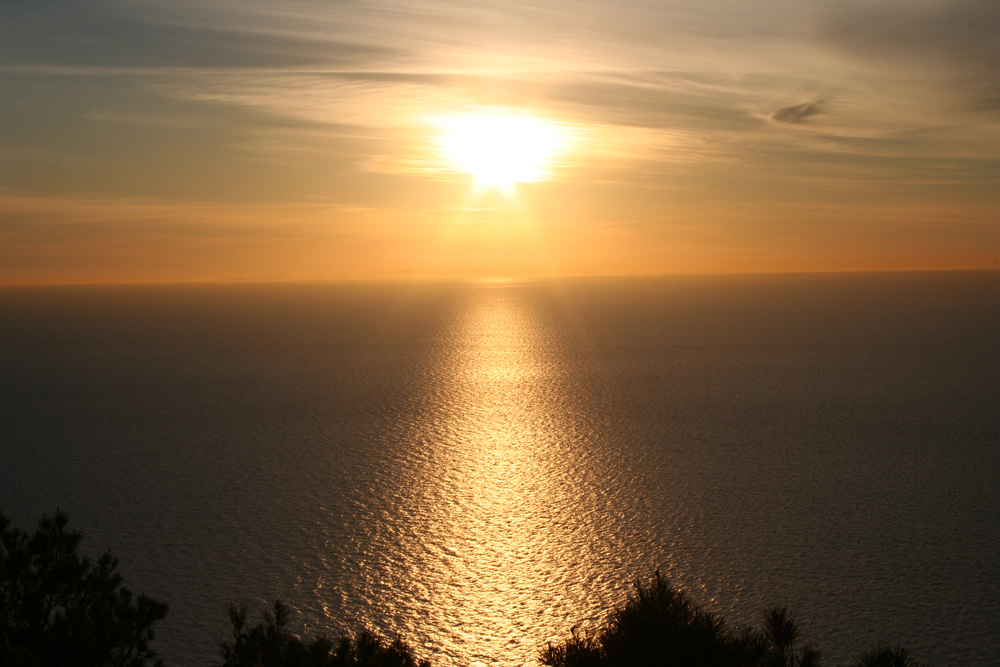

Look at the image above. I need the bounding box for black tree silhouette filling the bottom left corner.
[0,512,167,667]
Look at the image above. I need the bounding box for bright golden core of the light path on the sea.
[332,285,656,665]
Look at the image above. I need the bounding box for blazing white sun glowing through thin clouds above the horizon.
[440,114,562,188]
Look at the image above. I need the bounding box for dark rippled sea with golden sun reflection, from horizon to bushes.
[0,272,1000,667]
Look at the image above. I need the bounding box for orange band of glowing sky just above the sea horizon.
[0,168,1000,285]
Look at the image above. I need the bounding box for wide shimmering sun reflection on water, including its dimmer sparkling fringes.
[303,284,654,667]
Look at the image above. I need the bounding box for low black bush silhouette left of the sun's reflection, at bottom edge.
[222,600,430,667]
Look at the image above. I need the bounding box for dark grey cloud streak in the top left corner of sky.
[0,0,392,70]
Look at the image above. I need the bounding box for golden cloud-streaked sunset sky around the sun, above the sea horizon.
[0,0,1000,284]
